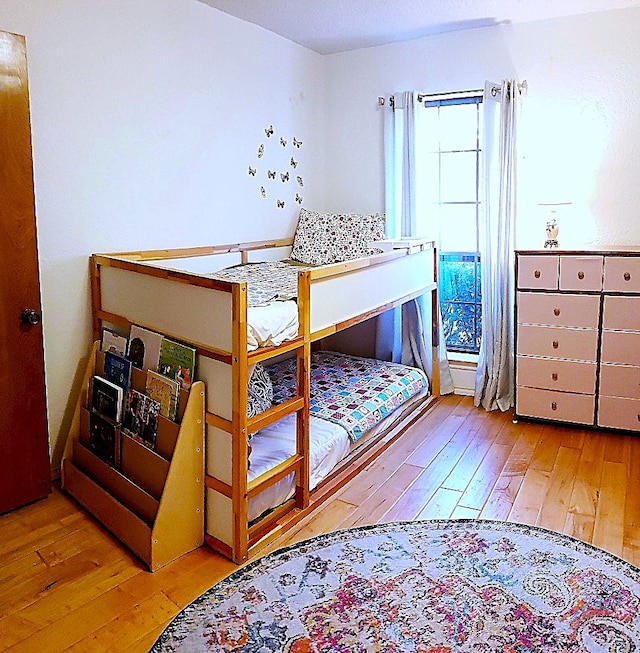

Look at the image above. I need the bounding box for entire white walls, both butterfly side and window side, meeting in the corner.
[0,0,640,467]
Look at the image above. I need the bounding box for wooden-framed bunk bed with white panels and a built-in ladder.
[84,224,438,563]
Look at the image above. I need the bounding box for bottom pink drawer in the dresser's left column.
[516,386,595,424]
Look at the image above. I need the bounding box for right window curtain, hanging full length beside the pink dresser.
[474,80,520,411]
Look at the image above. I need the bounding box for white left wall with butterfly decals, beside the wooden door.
[0,0,325,467]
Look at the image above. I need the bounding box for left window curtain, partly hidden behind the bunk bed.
[376,91,453,394]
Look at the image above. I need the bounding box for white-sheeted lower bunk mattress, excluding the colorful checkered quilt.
[247,389,430,521]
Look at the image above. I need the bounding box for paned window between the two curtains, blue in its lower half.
[418,91,482,354]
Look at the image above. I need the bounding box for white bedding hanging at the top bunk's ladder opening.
[247,300,298,351]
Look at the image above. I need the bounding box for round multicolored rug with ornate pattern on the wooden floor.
[151,520,640,653]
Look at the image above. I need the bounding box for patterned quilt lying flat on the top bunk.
[209,261,312,306]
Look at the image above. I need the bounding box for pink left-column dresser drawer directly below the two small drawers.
[518,292,600,329]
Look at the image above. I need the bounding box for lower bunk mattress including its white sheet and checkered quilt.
[248,352,430,521]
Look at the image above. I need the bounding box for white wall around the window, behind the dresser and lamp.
[326,8,640,247]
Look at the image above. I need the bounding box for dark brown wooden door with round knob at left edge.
[0,31,51,513]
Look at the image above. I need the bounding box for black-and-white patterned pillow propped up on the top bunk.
[291,209,385,265]
